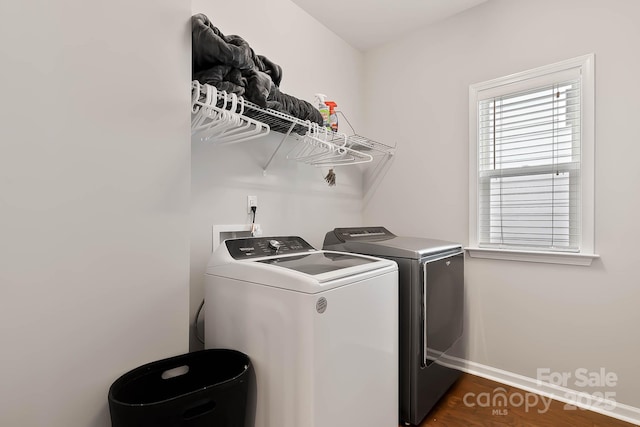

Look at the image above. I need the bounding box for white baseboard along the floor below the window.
[441,356,640,426]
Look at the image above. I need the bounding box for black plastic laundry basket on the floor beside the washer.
[109,349,251,427]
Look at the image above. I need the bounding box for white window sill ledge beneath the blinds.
[464,247,600,267]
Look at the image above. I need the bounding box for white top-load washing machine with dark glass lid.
[205,237,398,427]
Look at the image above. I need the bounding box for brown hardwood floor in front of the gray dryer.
[404,374,633,427]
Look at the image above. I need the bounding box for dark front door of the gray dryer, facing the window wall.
[421,251,464,366]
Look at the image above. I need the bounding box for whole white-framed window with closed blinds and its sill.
[468,55,596,265]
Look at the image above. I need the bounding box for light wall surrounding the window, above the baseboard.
[364,0,640,419]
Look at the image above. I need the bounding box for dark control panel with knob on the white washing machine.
[225,236,316,259]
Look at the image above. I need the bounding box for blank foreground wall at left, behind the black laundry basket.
[0,0,190,427]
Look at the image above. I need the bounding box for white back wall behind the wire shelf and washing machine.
[191,0,363,349]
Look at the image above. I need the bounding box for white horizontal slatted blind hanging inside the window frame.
[477,78,581,252]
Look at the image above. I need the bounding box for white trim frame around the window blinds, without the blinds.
[465,54,599,265]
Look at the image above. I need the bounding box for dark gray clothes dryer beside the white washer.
[323,227,464,425]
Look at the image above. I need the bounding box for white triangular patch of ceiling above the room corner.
[292,0,487,51]
